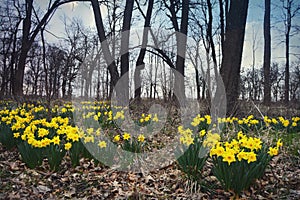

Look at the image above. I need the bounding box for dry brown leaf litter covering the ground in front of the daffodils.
[0,141,300,199]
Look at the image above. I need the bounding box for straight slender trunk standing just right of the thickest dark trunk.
[263,0,271,105]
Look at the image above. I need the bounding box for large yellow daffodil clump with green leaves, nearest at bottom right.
[210,131,283,196]
